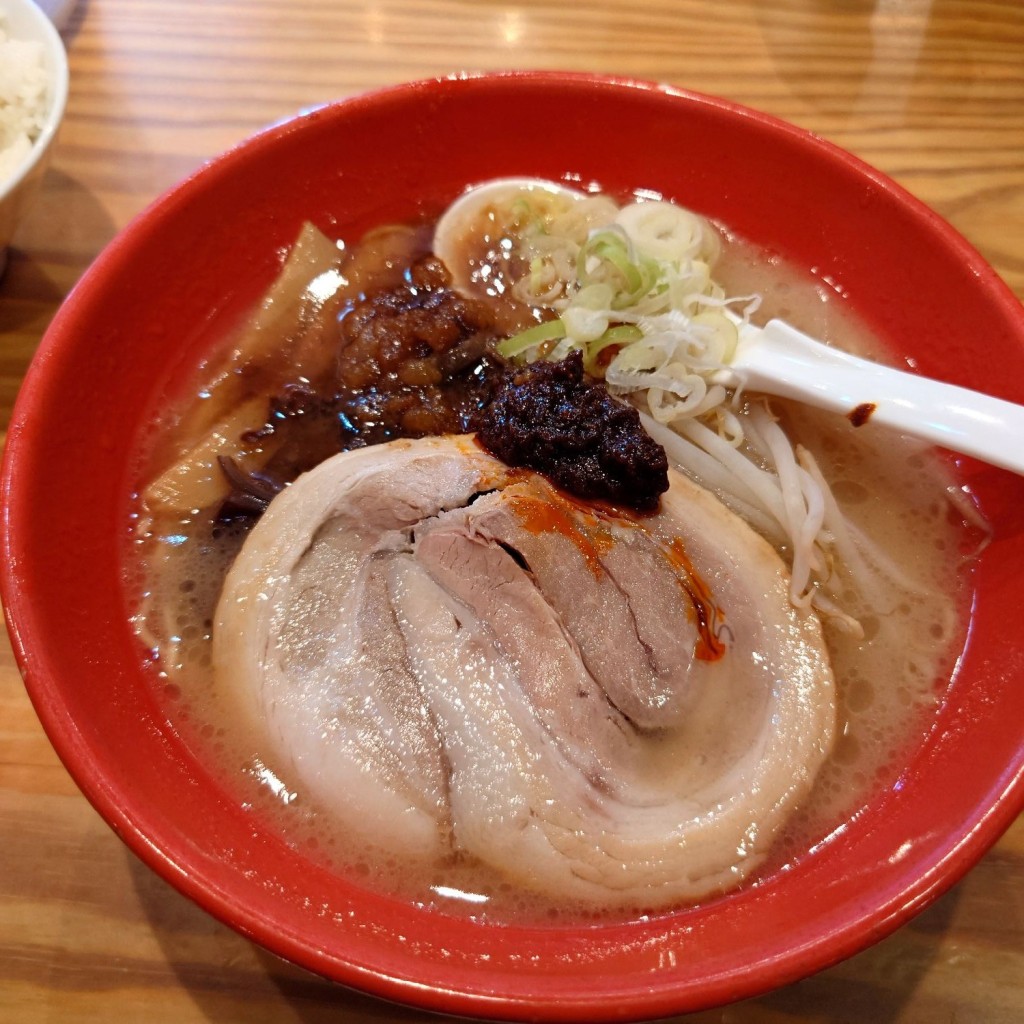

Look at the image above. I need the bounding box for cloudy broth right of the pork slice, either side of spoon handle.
[716,240,974,847]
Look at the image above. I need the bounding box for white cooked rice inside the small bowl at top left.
[0,14,46,185]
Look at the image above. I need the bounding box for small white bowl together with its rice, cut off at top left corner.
[0,0,68,270]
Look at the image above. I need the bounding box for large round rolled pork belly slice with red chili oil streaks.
[214,436,836,907]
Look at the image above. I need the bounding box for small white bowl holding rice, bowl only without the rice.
[0,0,68,272]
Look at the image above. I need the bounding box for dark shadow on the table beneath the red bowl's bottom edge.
[126,854,974,1024]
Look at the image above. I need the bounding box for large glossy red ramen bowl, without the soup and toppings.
[3,74,1024,1021]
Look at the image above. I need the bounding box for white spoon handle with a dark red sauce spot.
[731,319,1024,473]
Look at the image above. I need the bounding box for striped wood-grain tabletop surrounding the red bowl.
[0,0,1024,1024]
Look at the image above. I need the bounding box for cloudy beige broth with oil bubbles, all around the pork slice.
[131,195,977,920]
